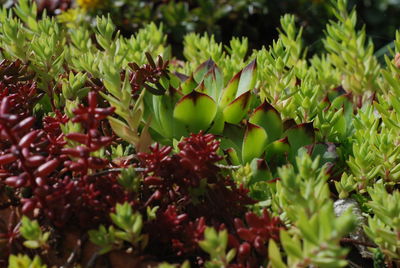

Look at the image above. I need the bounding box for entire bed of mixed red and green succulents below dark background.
[0,0,400,268]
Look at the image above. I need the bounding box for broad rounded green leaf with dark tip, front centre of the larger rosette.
[174,91,217,132]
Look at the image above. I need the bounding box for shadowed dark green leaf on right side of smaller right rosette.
[284,123,315,160]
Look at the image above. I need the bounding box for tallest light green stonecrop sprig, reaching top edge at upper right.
[324,0,380,99]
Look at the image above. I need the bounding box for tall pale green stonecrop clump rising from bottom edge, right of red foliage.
[268,154,357,268]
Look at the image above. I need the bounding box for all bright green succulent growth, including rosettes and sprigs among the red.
[0,0,400,267]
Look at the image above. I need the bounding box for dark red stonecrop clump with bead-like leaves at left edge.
[0,89,128,228]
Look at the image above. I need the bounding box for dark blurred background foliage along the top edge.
[0,0,400,58]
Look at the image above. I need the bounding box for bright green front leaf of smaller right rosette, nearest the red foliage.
[242,123,268,163]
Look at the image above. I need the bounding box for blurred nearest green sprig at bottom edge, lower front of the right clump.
[268,203,355,268]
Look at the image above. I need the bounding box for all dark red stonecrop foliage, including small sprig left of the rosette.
[0,57,283,268]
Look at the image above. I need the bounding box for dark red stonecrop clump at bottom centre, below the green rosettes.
[138,133,281,267]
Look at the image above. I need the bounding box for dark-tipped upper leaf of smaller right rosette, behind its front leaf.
[249,102,283,142]
